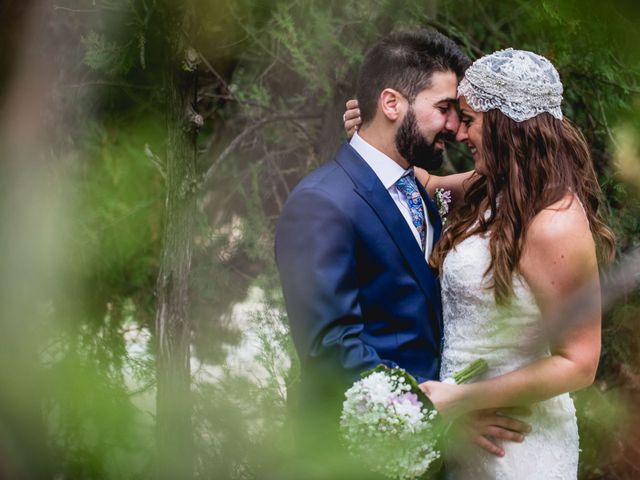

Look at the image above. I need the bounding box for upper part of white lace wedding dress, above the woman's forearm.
[440,235,548,378]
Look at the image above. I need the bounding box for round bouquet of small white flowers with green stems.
[340,360,487,479]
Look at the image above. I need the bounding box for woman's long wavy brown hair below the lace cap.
[430,110,615,305]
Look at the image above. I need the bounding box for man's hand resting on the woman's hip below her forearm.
[454,408,531,457]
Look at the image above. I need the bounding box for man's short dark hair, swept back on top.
[356,30,471,124]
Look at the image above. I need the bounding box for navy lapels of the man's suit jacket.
[336,144,440,304]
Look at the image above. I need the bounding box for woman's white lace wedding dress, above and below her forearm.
[440,231,579,480]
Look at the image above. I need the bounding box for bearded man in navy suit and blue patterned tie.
[276,31,528,462]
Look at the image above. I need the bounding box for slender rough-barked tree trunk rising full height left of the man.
[156,2,196,479]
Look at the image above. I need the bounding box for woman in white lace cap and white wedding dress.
[345,49,614,479]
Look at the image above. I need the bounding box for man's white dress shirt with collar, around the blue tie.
[349,132,433,260]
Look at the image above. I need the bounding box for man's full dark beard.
[395,107,445,170]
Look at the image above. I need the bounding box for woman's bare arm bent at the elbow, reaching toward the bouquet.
[422,200,601,416]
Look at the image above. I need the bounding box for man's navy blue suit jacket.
[276,144,442,401]
